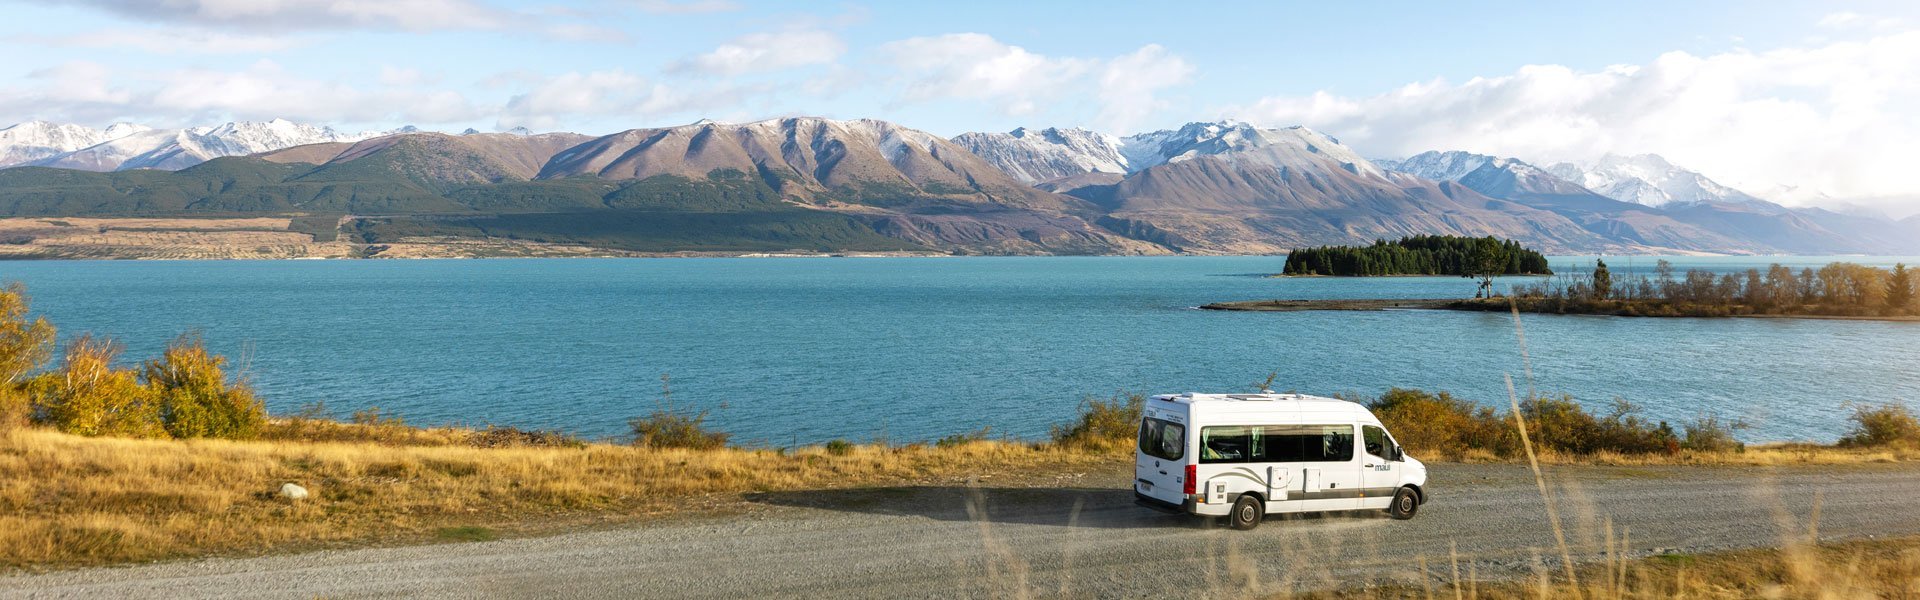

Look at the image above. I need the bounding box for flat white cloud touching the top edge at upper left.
[54,0,513,31]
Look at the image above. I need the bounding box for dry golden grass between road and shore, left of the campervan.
[0,425,1123,569]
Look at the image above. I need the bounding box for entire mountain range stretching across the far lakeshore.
[0,117,1920,254]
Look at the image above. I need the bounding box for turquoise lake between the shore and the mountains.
[0,258,1920,446]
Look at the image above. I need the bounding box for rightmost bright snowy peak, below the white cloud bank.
[1548,154,1772,208]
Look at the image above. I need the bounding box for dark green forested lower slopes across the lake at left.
[0,156,944,252]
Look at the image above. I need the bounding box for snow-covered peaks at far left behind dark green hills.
[27,119,405,171]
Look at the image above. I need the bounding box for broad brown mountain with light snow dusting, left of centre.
[538,117,1165,254]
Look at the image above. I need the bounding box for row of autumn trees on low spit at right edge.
[1453,260,1920,317]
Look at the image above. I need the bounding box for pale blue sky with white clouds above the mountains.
[0,0,1920,212]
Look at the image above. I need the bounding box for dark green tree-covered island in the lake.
[1284,235,1553,277]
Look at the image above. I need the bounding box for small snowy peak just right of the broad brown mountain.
[952,127,1129,185]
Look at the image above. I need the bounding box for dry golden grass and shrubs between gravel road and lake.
[0,280,1920,569]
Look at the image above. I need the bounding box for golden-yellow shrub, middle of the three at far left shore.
[31,337,167,437]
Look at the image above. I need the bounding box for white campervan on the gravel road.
[1133,394,1427,529]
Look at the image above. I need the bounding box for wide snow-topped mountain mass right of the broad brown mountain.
[956,121,1607,254]
